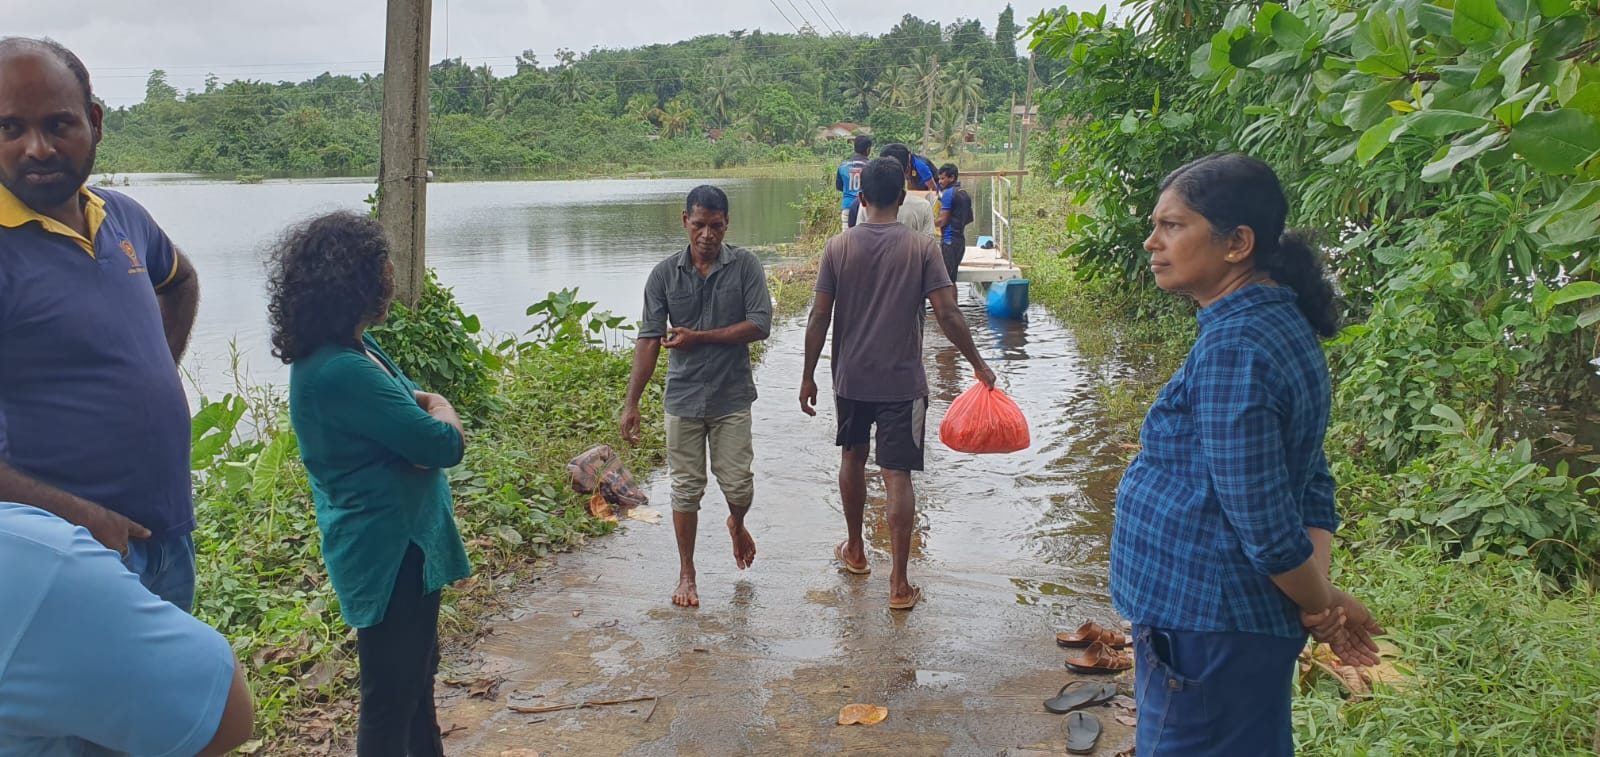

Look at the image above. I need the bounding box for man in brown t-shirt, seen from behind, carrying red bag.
[800,158,995,610]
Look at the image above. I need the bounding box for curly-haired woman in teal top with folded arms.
[267,213,472,757]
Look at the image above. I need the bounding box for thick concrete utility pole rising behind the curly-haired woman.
[378,0,434,307]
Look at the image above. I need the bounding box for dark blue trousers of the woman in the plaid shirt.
[1133,626,1306,757]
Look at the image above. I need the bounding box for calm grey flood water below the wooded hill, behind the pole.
[106,174,821,397]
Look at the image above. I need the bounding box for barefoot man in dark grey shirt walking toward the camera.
[622,186,773,607]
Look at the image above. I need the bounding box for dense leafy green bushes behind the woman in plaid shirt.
[1032,0,1600,576]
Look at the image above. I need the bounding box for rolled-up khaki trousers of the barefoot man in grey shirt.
[666,408,755,512]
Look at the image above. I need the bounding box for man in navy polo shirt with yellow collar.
[0,37,200,610]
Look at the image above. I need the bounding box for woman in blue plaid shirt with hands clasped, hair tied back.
[1110,154,1382,757]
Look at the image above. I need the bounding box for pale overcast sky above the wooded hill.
[9,0,1120,107]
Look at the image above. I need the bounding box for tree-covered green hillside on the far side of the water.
[99,8,1026,174]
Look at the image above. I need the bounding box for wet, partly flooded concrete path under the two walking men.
[440,294,1133,757]
